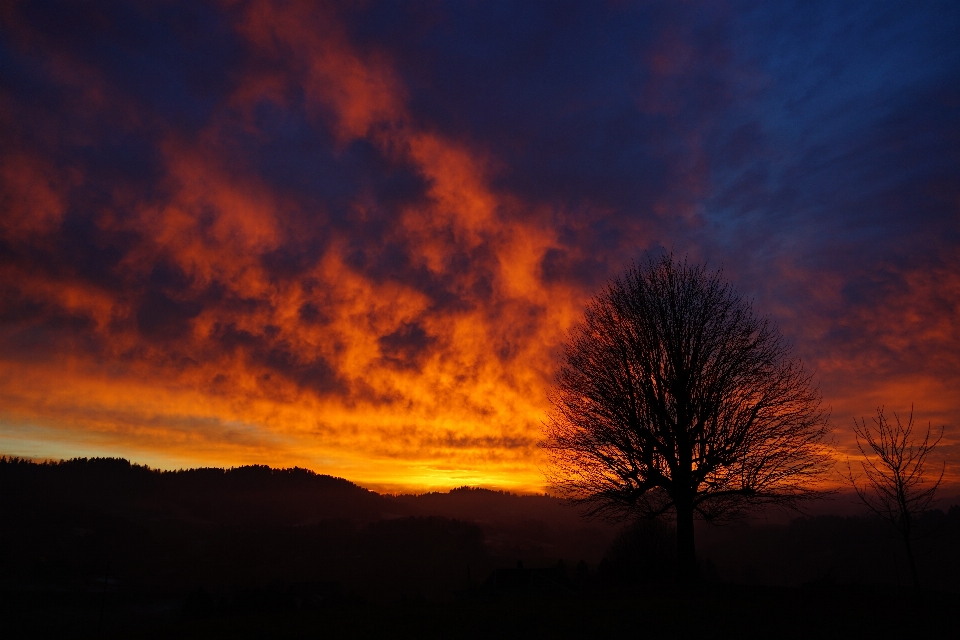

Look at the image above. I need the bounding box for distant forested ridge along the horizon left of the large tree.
[0,458,613,536]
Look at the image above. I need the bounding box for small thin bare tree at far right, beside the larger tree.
[847,406,946,589]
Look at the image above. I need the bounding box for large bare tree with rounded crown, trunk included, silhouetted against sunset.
[541,255,829,581]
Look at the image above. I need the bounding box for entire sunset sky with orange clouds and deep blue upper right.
[0,0,960,492]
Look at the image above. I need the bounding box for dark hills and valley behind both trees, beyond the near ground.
[0,458,960,597]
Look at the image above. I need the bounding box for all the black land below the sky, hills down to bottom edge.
[0,458,960,638]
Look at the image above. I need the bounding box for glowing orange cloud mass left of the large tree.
[3,3,584,489]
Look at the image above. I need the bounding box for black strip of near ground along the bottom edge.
[3,585,960,638]
